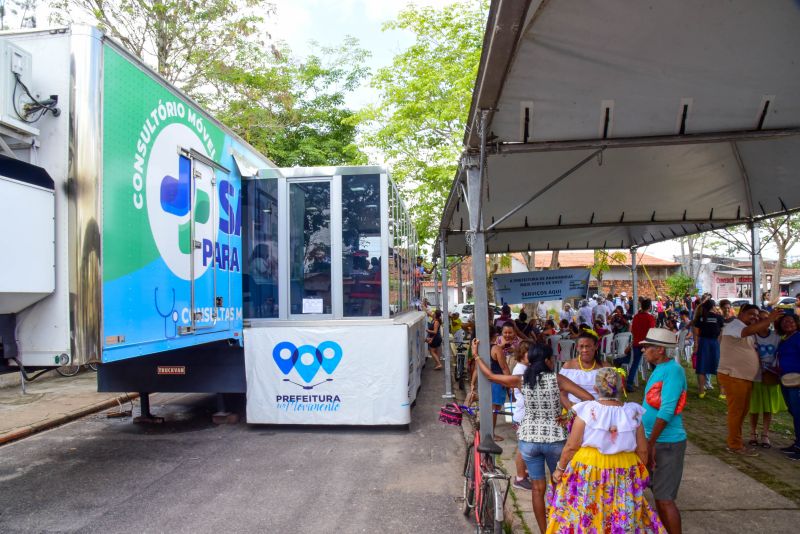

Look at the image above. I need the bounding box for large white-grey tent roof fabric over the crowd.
[441,0,800,255]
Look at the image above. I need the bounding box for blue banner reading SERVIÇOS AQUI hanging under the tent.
[494,269,589,304]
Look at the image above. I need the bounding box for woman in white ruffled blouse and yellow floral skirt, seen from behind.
[547,368,666,533]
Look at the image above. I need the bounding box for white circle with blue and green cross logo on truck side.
[146,123,219,280]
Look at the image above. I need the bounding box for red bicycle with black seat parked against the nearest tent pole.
[459,406,511,534]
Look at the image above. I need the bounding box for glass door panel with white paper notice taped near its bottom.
[289,180,333,318]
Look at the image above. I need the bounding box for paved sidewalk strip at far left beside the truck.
[0,371,138,445]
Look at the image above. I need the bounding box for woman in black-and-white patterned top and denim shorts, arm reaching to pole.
[472,339,593,532]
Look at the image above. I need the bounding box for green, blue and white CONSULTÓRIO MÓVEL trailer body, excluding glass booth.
[0,26,274,418]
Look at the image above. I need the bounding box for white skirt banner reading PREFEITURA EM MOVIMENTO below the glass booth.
[244,314,424,425]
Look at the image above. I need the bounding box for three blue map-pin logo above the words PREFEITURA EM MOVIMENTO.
[272,341,342,389]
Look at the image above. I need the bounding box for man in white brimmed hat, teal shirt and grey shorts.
[640,328,686,534]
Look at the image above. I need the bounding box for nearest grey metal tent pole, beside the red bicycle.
[467,110,497,447]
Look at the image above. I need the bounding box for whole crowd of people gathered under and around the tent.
[451,293,800,534]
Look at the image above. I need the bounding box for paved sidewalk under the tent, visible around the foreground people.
[463,404,800,534]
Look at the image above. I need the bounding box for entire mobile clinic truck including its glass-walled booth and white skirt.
[0,26,424,424]
